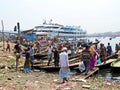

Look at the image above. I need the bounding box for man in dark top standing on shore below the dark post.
[14,40,22,71]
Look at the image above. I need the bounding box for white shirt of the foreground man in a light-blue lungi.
[59,52,69,67]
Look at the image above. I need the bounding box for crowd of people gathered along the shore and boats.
[6,40,120,83]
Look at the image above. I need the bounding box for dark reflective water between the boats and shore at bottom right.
[97,69,120,81]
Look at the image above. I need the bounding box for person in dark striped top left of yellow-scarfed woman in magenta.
[82,45,90,75]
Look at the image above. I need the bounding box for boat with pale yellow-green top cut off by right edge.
[110,58,120,72]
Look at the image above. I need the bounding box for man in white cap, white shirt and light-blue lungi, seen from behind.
[59,47,70,83]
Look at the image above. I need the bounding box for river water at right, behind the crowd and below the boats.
[89,37,120,81]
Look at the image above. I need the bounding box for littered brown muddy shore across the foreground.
[0,42,120,90]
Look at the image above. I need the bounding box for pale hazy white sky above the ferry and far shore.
[0,0,120,34]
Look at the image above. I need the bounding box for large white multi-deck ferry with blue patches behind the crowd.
[33,22,87,40]
